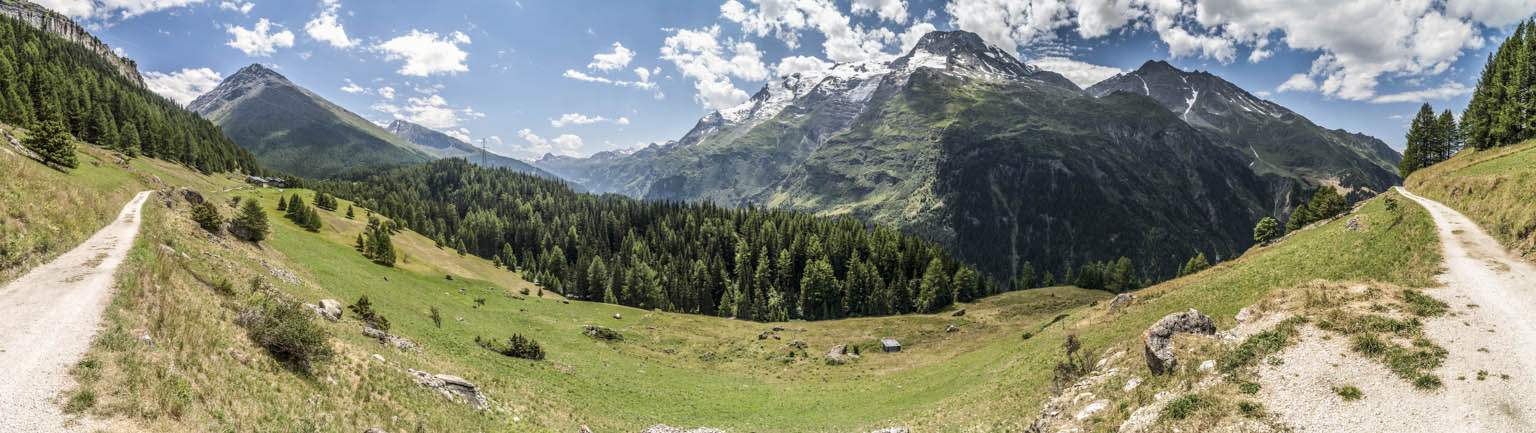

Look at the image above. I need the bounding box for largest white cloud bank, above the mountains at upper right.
[945,0,1536,100]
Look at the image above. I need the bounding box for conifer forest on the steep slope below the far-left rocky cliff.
[0,17,261,174]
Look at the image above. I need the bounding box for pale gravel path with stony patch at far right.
[1260,189,1536,431]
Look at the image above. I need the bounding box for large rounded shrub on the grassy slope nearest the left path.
[240,299,335,370]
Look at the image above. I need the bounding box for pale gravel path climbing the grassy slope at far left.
[0,190,151,431]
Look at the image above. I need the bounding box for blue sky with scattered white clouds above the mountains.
[34,0,1536,160]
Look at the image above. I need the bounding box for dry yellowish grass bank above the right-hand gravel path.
[1404,141,1536,258]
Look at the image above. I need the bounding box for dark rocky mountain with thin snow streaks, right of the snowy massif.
[1087,61,1402,207]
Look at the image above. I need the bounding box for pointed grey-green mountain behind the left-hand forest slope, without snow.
[187,64,433,178]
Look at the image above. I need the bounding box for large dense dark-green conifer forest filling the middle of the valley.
[315,158,998,321]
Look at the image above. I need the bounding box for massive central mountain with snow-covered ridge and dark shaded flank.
[535,31,1275,278]
